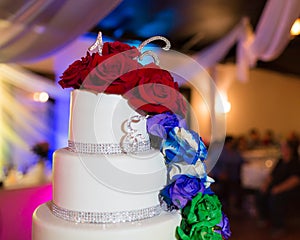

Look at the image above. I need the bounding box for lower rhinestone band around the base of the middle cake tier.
[49,202,161,224]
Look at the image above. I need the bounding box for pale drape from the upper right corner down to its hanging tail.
[237,0,300,81]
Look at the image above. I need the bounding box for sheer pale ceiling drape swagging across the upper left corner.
[0,0,121,63]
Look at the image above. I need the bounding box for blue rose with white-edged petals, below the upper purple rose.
[161,127,207,164]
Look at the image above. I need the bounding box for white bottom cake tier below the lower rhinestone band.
[32,203,180,240]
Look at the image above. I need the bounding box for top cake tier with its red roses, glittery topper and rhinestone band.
[59,34,186,154]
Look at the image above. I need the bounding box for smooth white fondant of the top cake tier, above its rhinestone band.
[69,90,149,144]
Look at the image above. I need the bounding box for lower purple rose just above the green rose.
[161,175,205,209]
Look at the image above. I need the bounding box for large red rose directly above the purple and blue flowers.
[124,68,186,116]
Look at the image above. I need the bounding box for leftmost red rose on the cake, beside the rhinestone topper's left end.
[58,52,96,89]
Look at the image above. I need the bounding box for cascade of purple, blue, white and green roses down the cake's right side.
[147,112,231,240]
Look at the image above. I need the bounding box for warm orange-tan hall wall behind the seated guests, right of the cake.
[191,65,300,141]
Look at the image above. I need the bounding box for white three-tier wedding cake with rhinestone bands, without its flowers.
[33,90,179,240]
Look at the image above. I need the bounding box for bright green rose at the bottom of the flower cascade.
[177,192,222,240]
